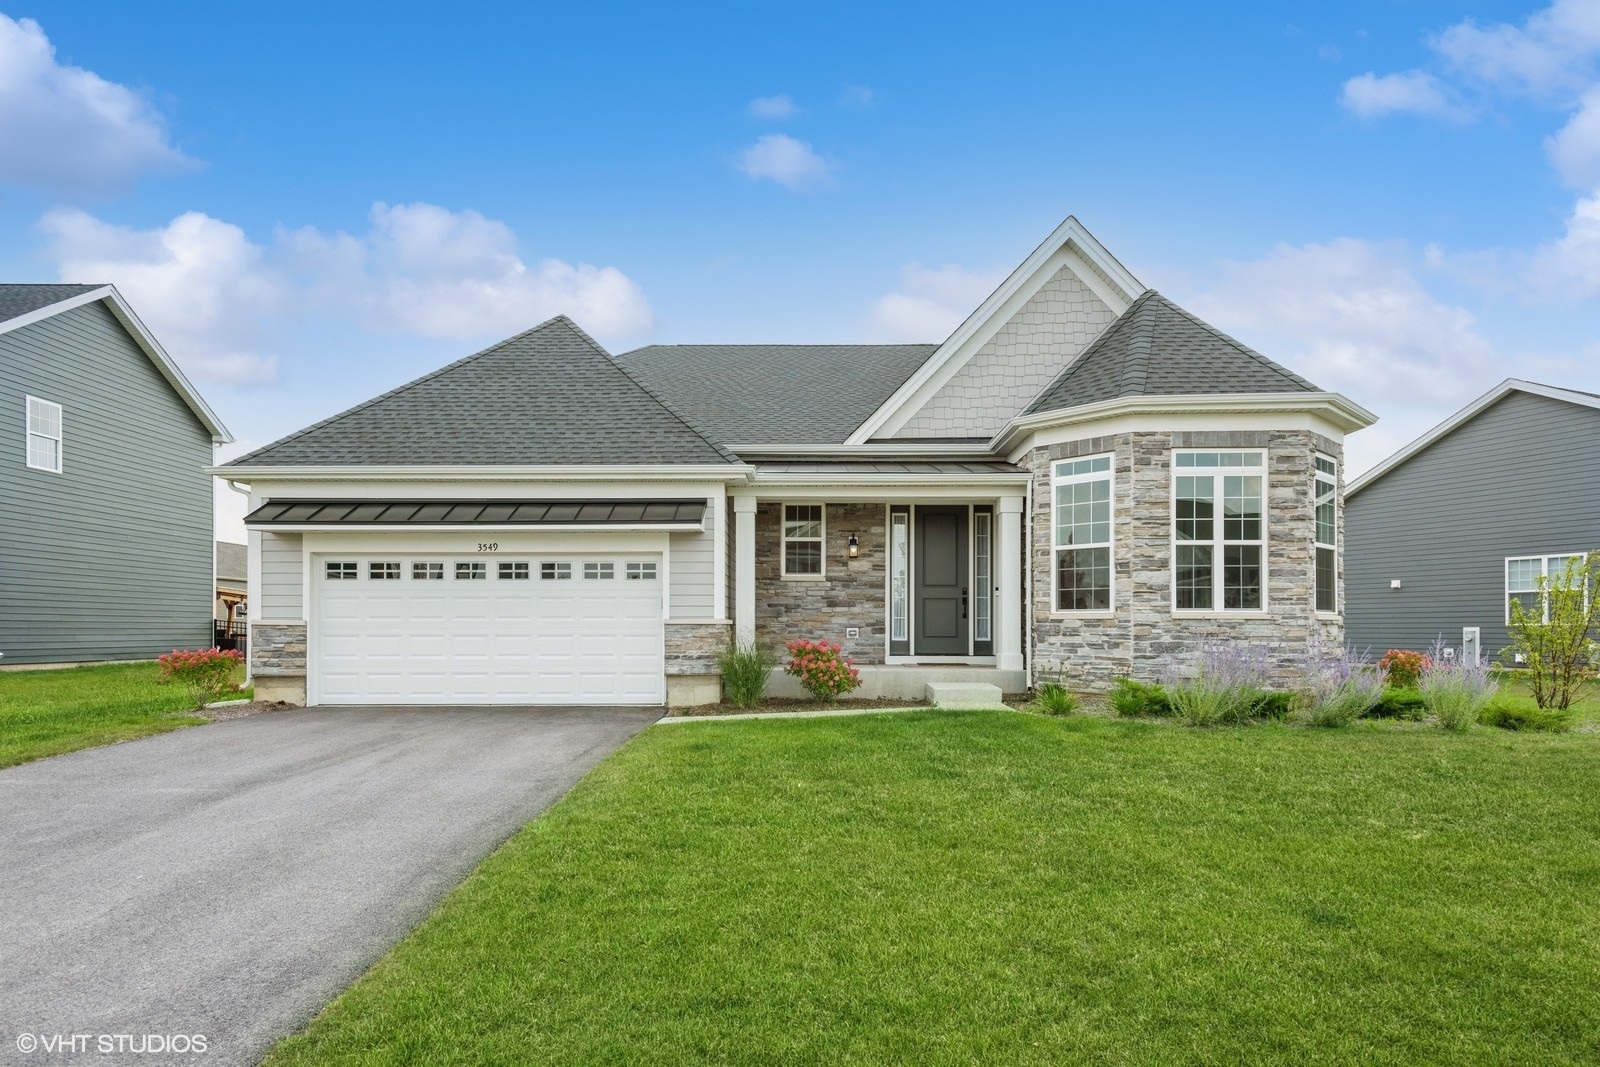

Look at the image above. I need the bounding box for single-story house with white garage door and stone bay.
[218,218,1373,704]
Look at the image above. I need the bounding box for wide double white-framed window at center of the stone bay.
[1173,451,1267,611]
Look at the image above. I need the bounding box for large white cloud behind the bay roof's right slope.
[1189,237,1504,406]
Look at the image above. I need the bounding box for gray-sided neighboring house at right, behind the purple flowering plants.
[1344,379,1600,659]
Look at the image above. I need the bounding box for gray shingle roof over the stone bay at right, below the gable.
[1024,290,1322,414]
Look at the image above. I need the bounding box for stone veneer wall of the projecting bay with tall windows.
[1026,430,1344,689]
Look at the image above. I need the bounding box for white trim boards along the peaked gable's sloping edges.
[845,214,1144,445]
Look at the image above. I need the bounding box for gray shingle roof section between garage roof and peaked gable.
[616,344,939,445]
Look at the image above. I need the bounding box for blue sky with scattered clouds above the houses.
[0,0,1600,534]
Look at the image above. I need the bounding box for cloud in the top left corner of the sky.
[0,14,195,194]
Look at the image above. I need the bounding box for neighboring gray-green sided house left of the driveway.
[0,285,232,667]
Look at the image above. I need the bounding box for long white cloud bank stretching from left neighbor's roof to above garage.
[40,203,653,384]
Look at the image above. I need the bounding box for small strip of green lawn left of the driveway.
[0,664,238,766]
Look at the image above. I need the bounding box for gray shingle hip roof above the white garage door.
[227,315,738,467]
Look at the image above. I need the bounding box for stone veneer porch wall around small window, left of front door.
[755,501,888,664]
